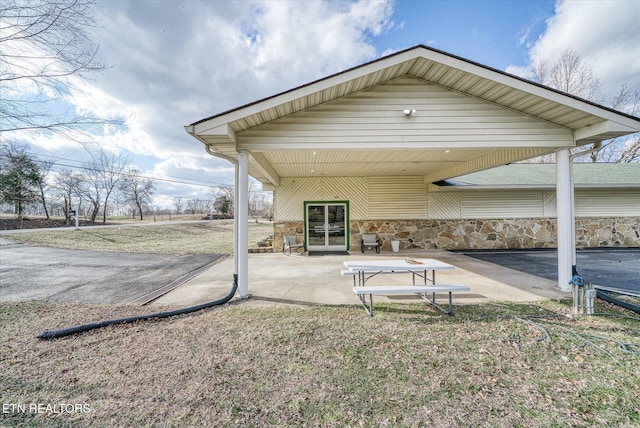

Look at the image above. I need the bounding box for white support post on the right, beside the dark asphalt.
[556,149,575,292]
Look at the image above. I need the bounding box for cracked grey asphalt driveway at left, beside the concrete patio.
[0,238,220,304]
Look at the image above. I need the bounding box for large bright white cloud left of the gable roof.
[11,0,394,207]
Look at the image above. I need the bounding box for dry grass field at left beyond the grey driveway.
[3,220,273,255]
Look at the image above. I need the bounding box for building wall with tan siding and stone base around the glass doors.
[274,177,640,251]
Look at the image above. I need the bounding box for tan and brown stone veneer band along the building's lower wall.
[273,217,640,251]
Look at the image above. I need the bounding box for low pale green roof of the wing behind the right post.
[448,163,640,187]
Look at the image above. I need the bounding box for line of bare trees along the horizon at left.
[0,141,272,224]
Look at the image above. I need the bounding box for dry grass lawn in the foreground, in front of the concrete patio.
[0,301,640,427]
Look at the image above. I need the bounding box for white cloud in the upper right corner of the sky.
[530,0,640,99]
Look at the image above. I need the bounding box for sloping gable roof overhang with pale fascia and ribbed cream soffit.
[190,45,640,131]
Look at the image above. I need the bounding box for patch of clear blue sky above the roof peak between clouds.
[374,0,554,70]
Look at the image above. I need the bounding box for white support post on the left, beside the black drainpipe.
[235,150,249,299]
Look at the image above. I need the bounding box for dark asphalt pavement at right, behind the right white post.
[459,248,640,292]
